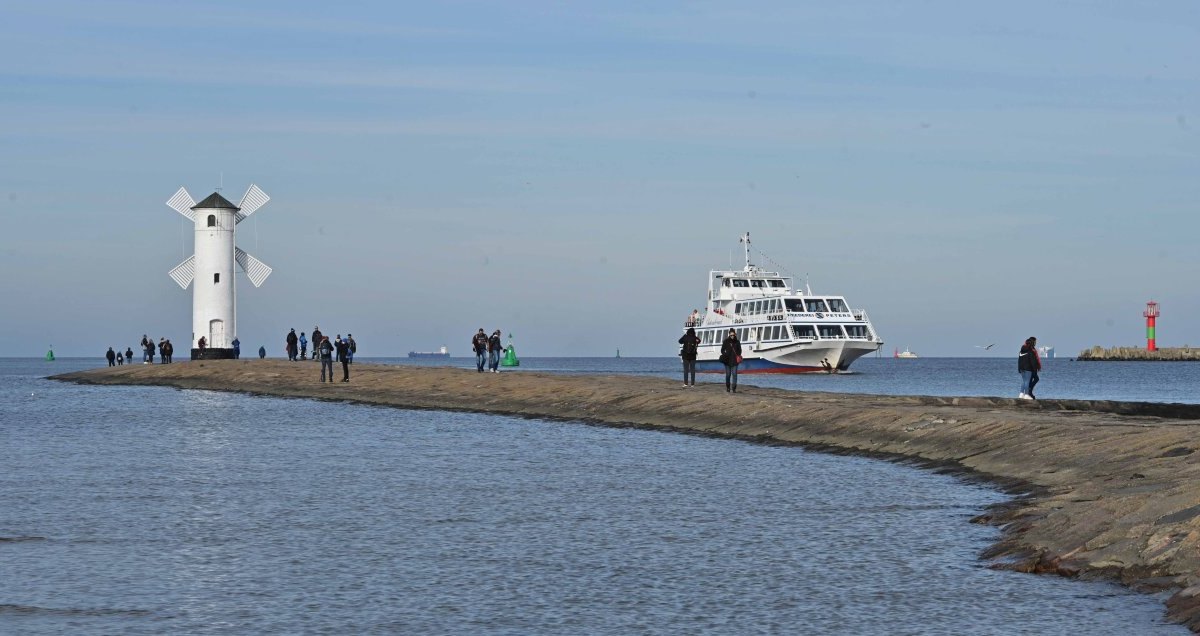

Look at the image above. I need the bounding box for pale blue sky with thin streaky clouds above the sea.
[0,0,1200,355]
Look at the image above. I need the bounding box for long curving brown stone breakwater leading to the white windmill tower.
[54,360,1200,631]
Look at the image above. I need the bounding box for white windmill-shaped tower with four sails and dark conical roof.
[167,184,271,360]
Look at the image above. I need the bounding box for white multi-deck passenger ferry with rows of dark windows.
[684,233,883,373]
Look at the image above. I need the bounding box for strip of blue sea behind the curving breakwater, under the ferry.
[388,356,1200,403]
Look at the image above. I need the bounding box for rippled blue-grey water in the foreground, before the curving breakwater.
[0,359,1187,635]
